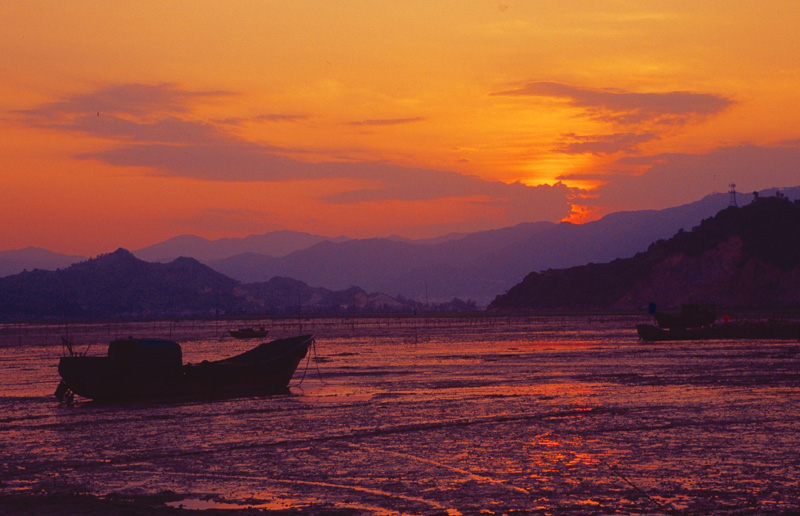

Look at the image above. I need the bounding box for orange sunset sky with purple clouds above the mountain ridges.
[0,0,800,256]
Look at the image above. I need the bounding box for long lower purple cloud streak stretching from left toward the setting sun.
[80,144,575,223]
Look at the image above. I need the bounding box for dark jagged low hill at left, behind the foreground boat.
[0,249,422,320]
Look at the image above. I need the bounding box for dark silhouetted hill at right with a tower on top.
[489,196,800,310]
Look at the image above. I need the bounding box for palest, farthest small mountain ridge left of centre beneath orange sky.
[133,231,347,263]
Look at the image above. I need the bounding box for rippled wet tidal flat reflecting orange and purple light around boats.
[0,317,800,516]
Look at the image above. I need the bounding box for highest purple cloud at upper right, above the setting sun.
[491,82,733,125]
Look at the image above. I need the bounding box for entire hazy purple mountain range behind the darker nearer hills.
[0,187,800,305]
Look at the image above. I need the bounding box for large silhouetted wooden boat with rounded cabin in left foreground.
[56,335,314,401]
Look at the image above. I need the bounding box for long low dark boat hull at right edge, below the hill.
[636,321,800,342]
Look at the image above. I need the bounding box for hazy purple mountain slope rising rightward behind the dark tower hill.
[209,187,800,304]
